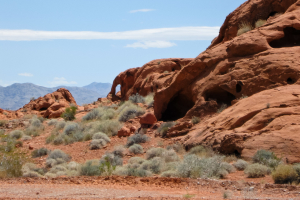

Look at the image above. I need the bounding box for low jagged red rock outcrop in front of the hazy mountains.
[16,88,76,118]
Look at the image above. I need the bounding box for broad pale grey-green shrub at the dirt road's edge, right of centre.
[177,154,228,178]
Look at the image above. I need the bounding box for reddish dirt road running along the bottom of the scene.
[0,176,300,200]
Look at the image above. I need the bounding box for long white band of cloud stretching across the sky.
[0,26,220,41]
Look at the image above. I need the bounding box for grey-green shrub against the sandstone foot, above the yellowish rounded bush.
[252,149,281,169]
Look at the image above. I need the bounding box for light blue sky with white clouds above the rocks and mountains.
[0,0,245,87]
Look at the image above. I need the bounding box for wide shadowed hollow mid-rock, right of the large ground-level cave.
[204,87,236,106]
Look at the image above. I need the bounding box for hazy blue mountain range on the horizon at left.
[0,82,112,110]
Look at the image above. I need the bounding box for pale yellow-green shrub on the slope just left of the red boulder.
[117,101,145,122]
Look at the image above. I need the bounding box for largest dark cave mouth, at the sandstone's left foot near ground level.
[160,93,195,121]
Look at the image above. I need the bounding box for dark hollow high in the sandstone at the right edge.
[269,27,300,48]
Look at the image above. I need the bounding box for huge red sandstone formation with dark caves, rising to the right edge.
[110,0,300,162]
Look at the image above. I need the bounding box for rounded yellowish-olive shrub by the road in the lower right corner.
[272,165,298,184]
